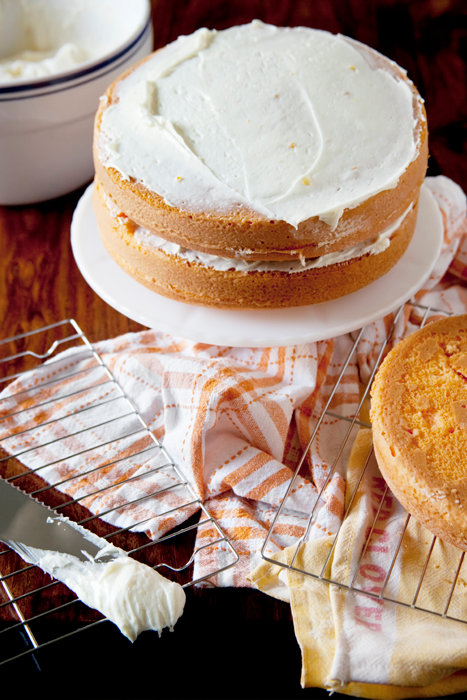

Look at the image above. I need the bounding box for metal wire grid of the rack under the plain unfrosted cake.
[261,304,467,624]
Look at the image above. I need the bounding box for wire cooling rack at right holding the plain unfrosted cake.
[261,304,467,624]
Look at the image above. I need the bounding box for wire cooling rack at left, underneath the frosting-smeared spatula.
[0,319,239,665]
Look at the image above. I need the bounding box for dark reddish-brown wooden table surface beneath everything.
[0,0,467,698]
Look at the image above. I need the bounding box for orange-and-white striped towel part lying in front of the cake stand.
[0,331,352,585]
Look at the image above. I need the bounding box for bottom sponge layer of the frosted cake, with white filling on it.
[93,178,418,309]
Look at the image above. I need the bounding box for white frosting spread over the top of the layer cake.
[99,21,418,228]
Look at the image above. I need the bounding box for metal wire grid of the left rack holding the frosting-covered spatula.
[0,319,239,665]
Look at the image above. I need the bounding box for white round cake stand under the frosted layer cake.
[71,185,443,347]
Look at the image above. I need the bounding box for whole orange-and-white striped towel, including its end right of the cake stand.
[0,172,467,586]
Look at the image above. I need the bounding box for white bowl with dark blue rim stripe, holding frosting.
[0,0,153,205]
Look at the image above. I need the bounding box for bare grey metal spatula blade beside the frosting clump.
[0,479,115,564]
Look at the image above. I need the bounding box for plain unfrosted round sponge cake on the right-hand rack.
[370,315,467,551]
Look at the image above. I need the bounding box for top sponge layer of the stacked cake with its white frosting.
[94,22,428,261]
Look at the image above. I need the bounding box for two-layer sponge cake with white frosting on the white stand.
[94,21,428,308]
